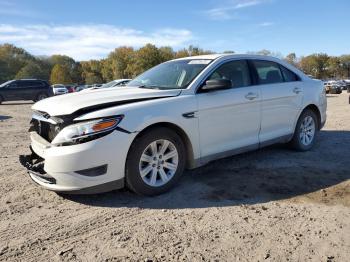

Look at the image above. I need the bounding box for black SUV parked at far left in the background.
[0,79,53,104]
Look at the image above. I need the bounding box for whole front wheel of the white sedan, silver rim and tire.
[125,128,186,196]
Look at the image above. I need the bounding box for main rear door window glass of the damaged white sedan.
[253,60,283,84]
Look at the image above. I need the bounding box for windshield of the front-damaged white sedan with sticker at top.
[127,59,212,89]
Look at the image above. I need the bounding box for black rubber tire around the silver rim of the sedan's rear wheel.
[290,109,319,151]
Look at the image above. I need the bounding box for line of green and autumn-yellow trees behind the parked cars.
[0,44,350,84]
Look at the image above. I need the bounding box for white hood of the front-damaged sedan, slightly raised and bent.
[32,87,181,116]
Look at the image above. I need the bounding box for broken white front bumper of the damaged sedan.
[20,131,134,194]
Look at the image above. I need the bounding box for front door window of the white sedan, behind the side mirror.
[208,60,251,87]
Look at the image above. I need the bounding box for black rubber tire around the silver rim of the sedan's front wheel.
[125,128,186,196]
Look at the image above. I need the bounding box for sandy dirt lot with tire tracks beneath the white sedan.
[0,93,350,261]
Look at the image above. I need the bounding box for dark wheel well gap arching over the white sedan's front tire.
[135,122,195,168]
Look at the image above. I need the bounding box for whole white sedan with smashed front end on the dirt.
[22,54,327,195]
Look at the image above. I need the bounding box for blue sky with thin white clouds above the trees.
[0,0,350,60]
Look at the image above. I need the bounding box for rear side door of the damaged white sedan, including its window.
[251,60,303,142]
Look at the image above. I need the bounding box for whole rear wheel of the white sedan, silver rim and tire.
[291,109,319,151]
